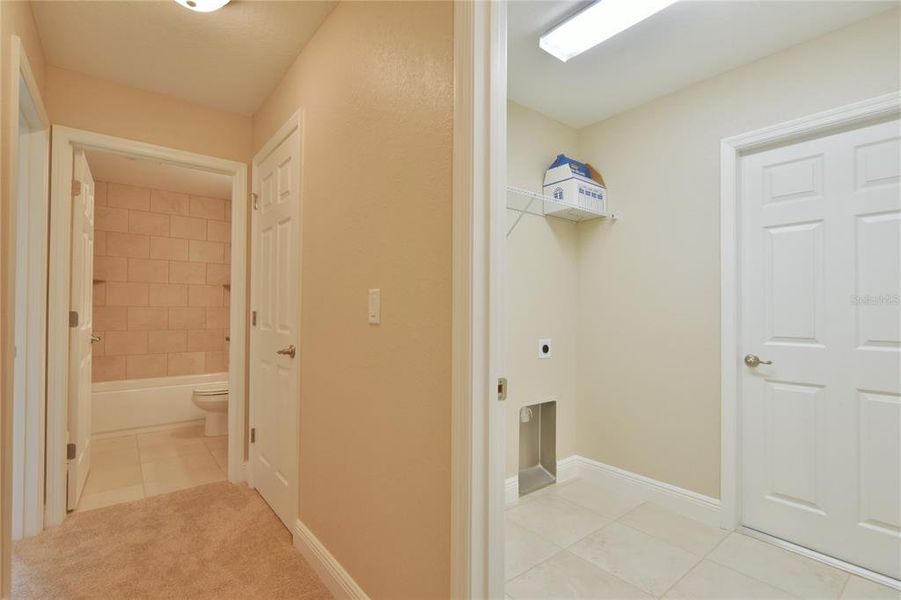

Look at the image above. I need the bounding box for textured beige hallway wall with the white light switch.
[254,2,453,599]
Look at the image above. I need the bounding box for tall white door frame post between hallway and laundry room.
[451,0,507,598]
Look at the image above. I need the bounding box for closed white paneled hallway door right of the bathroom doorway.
[250,122,301,529]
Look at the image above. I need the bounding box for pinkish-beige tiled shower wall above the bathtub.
[93,181,231,381]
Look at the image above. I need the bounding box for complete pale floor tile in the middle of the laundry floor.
[569,523,702,596]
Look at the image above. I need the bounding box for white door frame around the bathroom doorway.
[45,125,247,526]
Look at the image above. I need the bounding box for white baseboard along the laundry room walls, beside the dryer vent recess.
[504,455,720,527]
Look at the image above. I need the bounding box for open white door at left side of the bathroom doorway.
[66,150,94,510]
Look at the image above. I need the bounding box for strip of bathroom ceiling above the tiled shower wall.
[85,150,232,199]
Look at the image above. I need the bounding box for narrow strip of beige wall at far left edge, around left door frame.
[0,2,45,597]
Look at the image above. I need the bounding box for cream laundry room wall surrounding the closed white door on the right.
[578,11,901,497]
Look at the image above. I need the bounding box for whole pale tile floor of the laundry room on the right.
[505,479,901,600]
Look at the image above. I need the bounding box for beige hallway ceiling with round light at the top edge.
[32,0,336,115]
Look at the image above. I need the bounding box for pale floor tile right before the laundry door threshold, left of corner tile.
[708,533,848,599]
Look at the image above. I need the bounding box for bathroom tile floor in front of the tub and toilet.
[76,426,228,511]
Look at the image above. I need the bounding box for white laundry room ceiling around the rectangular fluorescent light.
[507,0,898,128]
